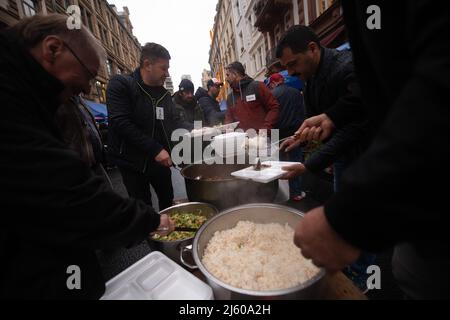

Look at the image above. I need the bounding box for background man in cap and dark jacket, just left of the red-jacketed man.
[195,78,225,127]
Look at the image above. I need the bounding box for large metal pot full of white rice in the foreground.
[185,204,325,300]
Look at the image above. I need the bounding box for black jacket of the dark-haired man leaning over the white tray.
[305,48,368,172]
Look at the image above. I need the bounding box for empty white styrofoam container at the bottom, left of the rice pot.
[101,251,214,300]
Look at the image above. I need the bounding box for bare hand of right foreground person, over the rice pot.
[294,207,361,272]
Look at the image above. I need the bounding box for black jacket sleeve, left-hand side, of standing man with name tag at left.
[106,76,163,159]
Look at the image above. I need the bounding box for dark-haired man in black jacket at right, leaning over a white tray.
[277,26,367,190]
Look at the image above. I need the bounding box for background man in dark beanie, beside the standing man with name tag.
[172,79,204,131]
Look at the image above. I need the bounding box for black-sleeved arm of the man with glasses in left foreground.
[0,109,160,250]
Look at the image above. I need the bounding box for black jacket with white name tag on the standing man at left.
[106,69,183,174]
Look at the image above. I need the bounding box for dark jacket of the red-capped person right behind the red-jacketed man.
[272,84,305,139]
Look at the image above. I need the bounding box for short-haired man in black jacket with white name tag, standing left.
[106,43,183,210]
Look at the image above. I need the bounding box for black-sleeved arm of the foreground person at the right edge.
[325,1,450,250]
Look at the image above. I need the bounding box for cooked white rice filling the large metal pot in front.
[202,221,319,291]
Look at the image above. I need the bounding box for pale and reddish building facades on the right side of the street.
[210,0,347,81]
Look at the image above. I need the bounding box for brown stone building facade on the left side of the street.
[0,0,141,103]
